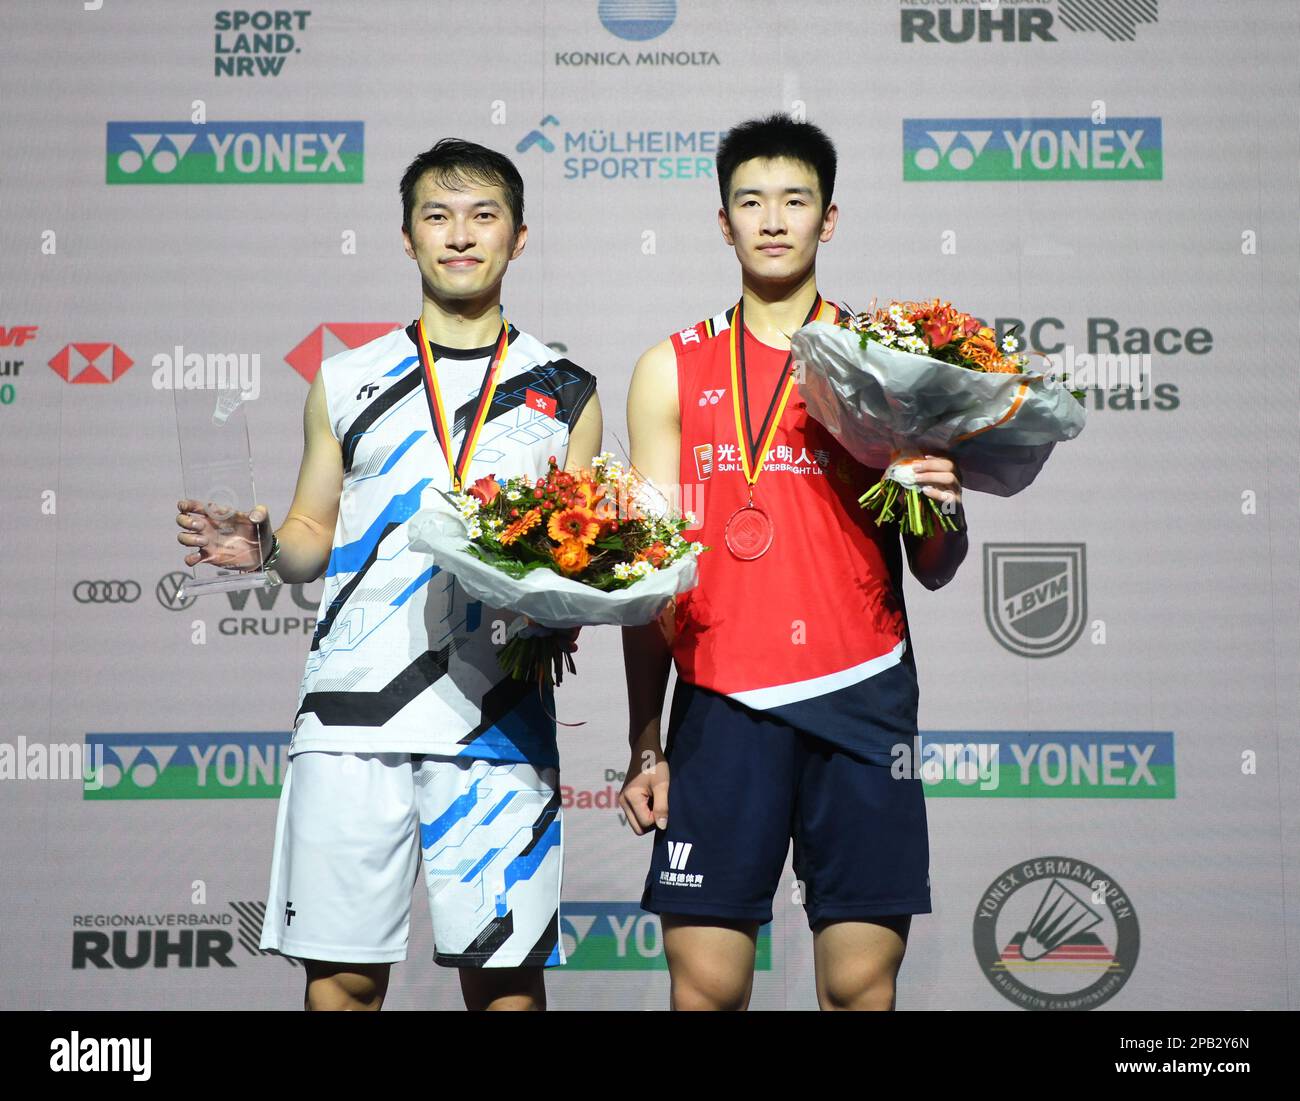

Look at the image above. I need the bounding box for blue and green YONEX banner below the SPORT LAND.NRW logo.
[105,121,365,183]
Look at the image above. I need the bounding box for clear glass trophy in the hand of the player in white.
[172,386,280,604]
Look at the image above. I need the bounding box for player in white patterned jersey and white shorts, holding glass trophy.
[177,139,601,1009]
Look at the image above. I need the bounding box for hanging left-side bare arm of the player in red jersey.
[619,341,681,835]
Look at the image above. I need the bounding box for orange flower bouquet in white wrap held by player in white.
[410,451,707,684]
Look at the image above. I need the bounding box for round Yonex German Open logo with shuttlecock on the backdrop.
[975,857,1139,1010]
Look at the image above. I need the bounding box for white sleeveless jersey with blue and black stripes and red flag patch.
[289,322,595,766]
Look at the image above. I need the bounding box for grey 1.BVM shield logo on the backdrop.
[984,543,1088,658]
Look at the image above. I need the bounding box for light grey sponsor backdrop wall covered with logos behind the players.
[0,0,1300,1010]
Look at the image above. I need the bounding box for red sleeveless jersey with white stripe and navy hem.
[672,303,917,764]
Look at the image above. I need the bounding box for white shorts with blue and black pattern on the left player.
[260,751,564,967]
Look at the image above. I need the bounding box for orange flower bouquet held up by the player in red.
[792,298,1084,536]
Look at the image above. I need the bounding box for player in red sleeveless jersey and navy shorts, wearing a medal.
[620,116,967,1009]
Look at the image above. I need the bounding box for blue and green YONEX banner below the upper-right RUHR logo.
[902,118,1164,183]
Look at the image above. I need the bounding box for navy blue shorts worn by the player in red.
[641,679,931,928]
